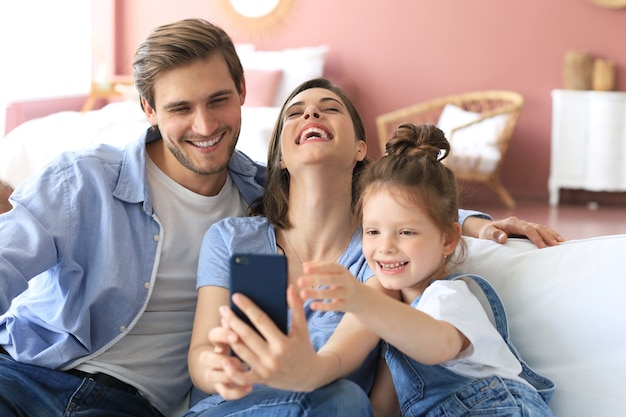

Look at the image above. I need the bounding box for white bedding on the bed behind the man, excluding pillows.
[0,102,280,188]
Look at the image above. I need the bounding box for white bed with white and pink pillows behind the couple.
[0,44,328,188]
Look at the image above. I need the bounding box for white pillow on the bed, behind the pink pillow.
[238,45,328,107]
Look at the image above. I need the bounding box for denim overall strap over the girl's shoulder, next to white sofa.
[446,273,555,404]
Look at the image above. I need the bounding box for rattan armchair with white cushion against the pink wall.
[376,90,524,208]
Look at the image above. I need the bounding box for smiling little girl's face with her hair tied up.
[363,188,458,301]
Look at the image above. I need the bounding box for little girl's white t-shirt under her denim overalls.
[415,280,530,385]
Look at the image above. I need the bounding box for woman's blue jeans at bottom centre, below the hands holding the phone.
[183,379,373,417]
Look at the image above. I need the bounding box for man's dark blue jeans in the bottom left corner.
[0,353,160,417]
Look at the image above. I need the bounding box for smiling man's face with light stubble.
[144,54,245,192]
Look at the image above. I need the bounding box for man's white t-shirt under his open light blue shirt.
[77,158,248,415]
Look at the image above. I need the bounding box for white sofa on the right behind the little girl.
[458,235,626,417]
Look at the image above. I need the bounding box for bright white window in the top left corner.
[0,0,92,102]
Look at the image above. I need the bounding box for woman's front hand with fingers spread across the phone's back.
[220,278,326,392]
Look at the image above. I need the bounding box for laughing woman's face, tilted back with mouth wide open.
[281,88,367,173]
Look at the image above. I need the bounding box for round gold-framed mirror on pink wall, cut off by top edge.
[221,0,295,32]
